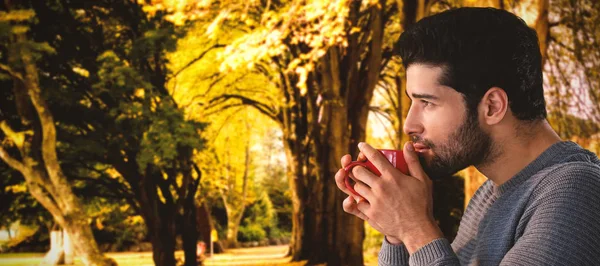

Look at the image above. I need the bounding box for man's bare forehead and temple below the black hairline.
[406,64,461,98]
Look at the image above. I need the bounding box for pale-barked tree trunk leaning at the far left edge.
[0,6,114,265]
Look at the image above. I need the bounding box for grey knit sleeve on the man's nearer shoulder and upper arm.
[501,163,600,265]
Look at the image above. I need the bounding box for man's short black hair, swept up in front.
[398,7,546,121]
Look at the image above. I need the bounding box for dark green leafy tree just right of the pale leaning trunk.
[1,1,211,265]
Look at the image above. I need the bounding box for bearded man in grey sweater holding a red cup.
[335,8,600,265]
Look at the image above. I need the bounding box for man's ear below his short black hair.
[479,87,509,125]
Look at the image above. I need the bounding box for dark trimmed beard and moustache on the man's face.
[411,112,495,179]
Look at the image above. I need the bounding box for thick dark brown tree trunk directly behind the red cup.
[284,1,385,265]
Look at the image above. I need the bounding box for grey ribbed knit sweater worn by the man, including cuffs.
[379,142,600,265]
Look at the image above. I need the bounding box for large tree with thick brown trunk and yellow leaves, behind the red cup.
[148,1,397,264]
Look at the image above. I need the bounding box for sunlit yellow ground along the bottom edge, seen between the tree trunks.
[0,246,377,266]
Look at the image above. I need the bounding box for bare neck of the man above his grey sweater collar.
[475,120,561,186]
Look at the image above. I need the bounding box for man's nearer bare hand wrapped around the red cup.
[336,142,442,253]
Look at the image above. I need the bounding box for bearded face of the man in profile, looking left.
[404,65,492,179]
